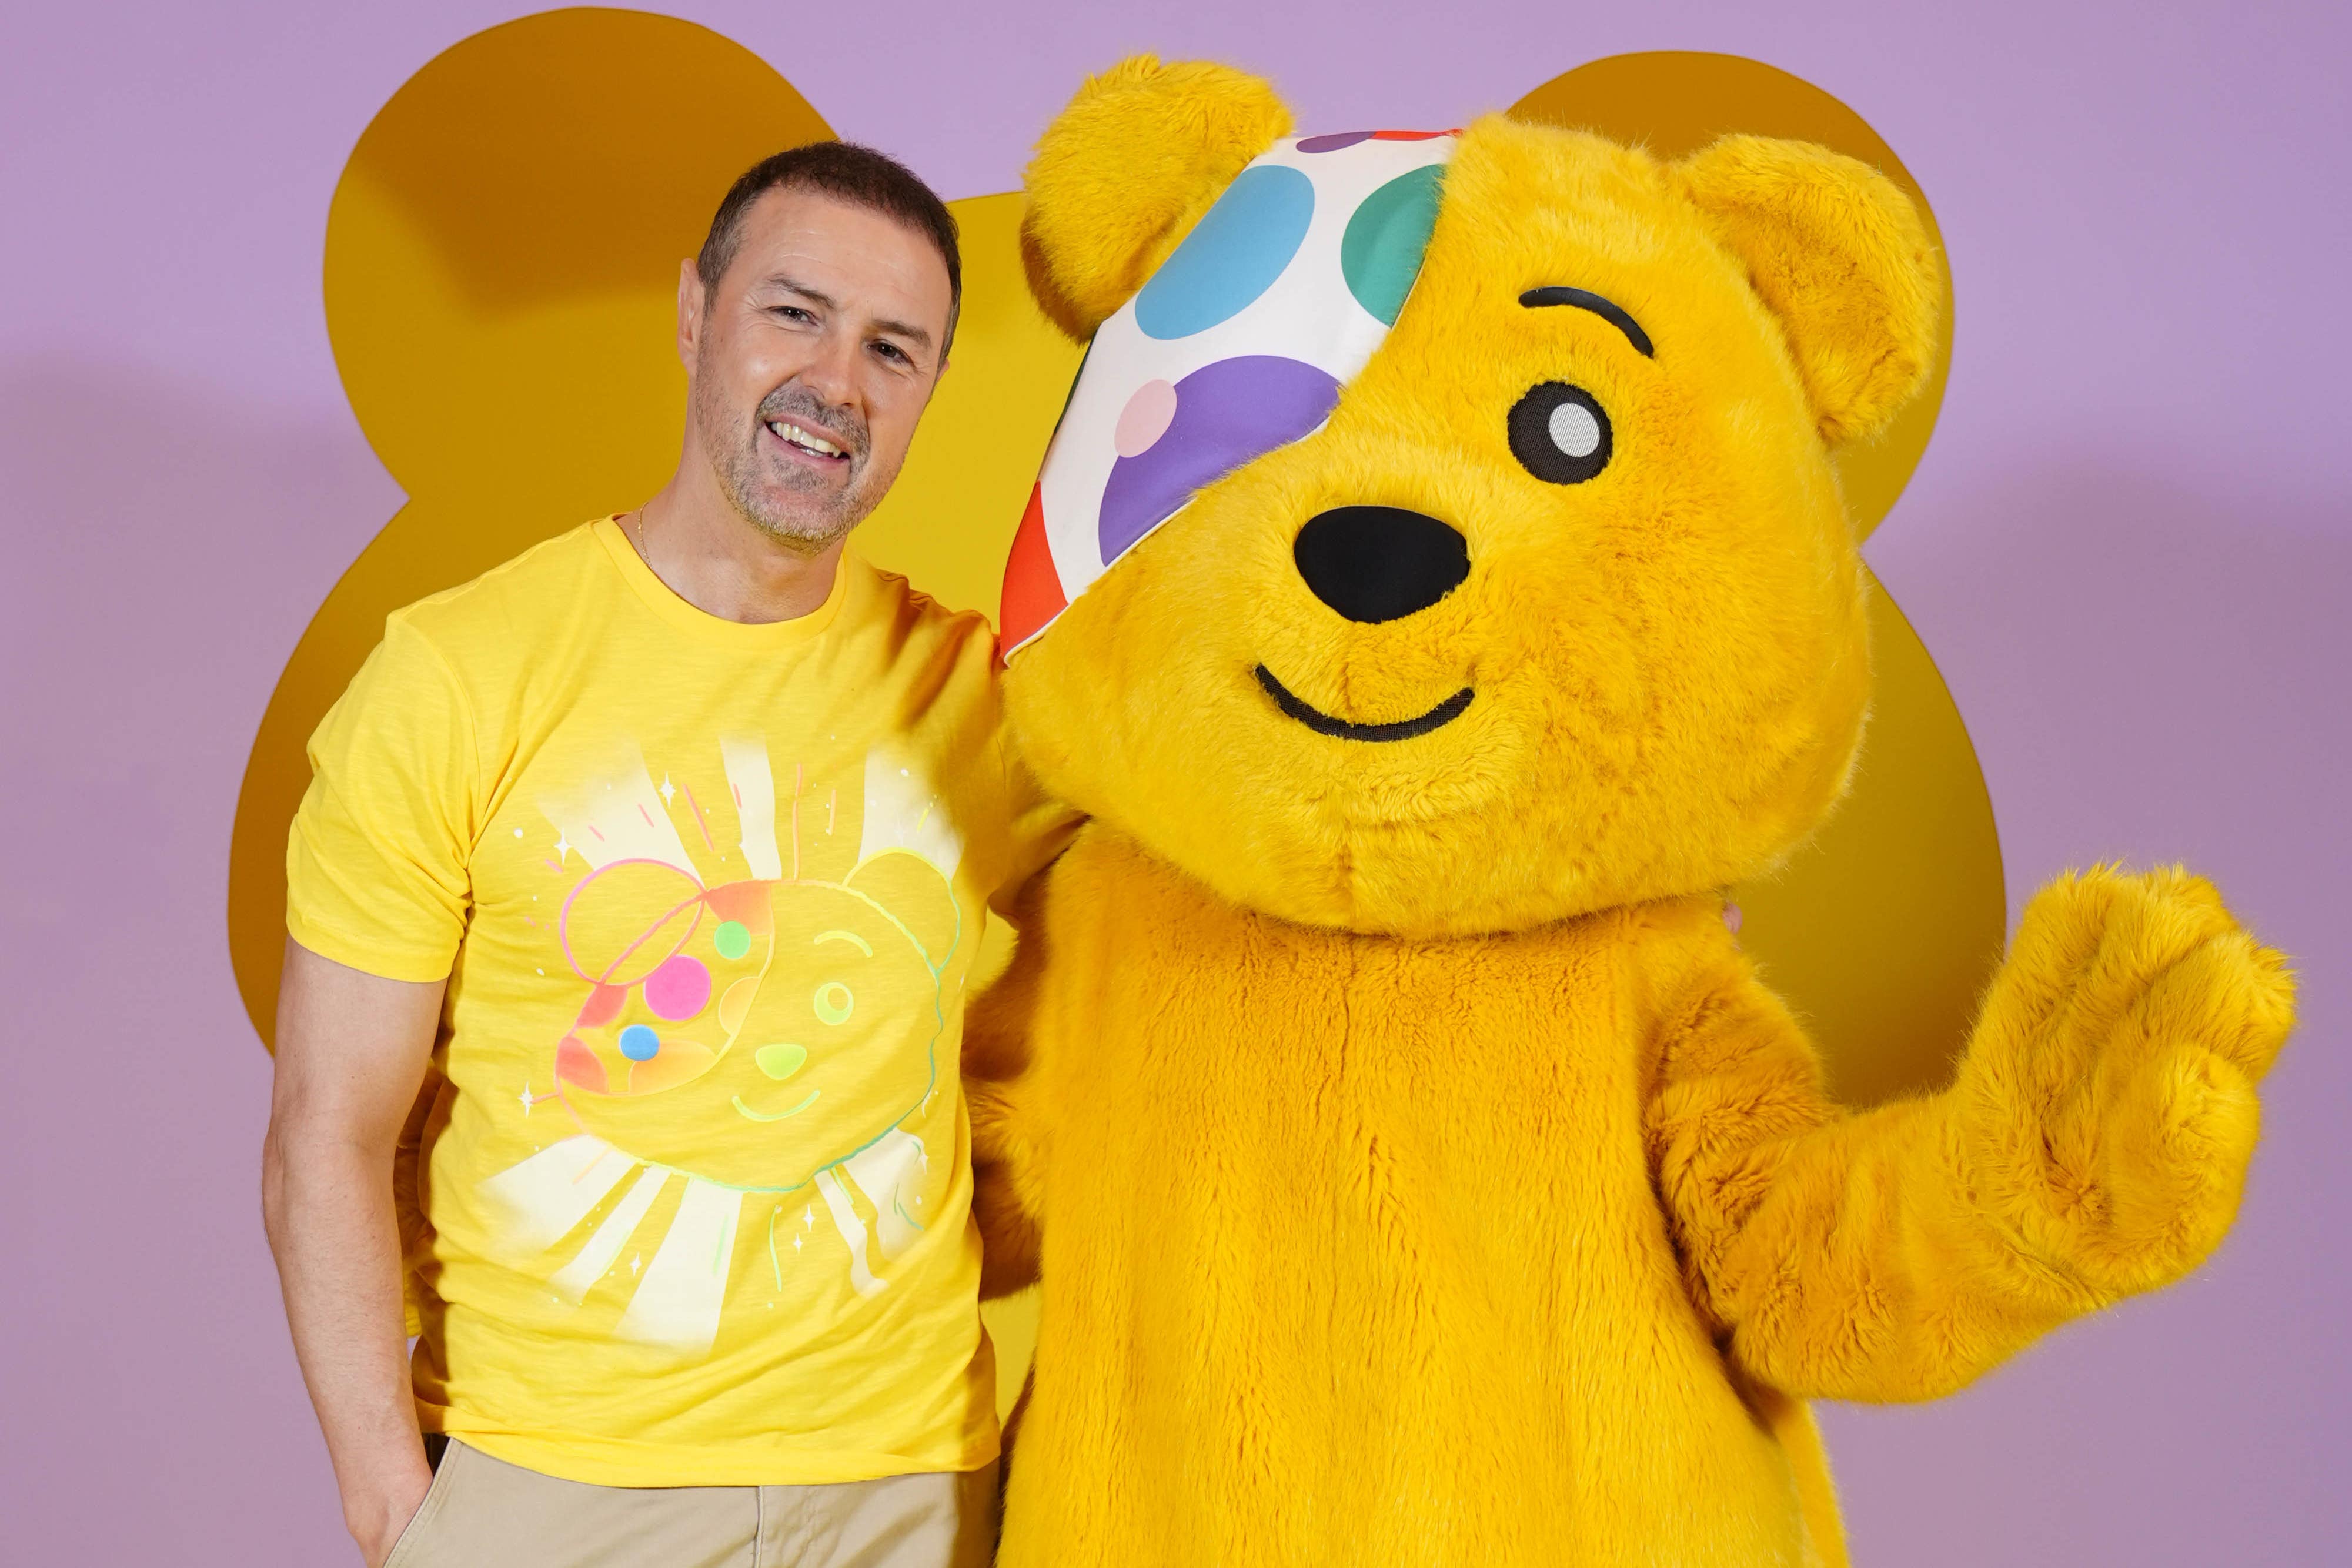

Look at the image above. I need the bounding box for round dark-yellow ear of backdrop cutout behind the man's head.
[325,9,833,512]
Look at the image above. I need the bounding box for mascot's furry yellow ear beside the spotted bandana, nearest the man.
[1021,54,1291,339]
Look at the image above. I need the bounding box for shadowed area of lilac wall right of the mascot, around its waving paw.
[1823,453,2352,1568]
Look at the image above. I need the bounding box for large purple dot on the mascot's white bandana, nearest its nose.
[1101,355,1338,564]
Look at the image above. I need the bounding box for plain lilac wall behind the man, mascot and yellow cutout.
[0,0,2352,1568]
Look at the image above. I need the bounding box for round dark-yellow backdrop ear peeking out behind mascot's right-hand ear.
[1510,49,1952,539]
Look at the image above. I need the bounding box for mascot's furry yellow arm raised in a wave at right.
[1649,870,2293,1399]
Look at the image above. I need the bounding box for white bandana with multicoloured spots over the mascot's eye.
[1002,132,1456,651]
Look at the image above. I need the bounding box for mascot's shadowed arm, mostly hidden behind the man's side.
[964,870,1054,1298]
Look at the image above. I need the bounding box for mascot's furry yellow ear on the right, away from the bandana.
[1675,136,1943,447]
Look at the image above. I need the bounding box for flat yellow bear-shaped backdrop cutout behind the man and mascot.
[228,9,2004,1396]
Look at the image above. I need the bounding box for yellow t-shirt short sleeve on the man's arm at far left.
[287,616,480,980]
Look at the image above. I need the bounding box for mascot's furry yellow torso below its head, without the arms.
[1002,827,1837,1568]
